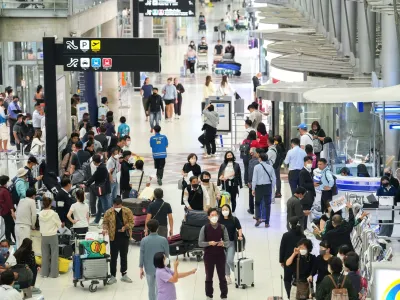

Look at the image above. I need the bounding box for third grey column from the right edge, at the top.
[342,0,357,56]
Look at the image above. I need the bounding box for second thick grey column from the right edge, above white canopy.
[357,2,376,74]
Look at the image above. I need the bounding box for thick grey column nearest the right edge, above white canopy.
[381,14,400,86]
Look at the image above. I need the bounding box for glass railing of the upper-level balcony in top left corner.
[0,0,107,18]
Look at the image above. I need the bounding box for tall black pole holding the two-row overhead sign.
[43,37,59,175]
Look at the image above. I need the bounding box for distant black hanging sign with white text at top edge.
[141,0,196,17]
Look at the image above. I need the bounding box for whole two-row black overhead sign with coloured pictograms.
[60,38,160,72]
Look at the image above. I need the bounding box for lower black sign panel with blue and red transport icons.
[63,55,160,72]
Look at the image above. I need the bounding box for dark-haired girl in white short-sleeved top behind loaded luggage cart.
[67,190,89,234]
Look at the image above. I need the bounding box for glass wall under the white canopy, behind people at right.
[275,102,382,176]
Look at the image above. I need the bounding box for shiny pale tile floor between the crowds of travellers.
[37,1,298,300]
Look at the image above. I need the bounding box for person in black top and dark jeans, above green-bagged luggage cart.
[85,154,111,226]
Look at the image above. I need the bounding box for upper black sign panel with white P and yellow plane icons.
[64,38,160,55]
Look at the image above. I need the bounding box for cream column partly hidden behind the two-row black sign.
[101,18,119,110]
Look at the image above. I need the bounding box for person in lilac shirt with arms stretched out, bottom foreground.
[154,252,197,300]
